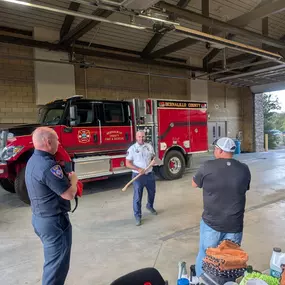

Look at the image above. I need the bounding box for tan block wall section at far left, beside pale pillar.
[0,43,37,125]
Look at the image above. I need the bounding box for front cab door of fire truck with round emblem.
[62,101,100,154]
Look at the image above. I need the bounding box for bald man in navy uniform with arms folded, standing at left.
[25,127,78,285]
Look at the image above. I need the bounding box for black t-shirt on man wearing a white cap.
[193,159,251,233]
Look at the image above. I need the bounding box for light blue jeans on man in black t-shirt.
[195,219,242,277]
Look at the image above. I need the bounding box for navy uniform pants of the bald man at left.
[32,214,72,285]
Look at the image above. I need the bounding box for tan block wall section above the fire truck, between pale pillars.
[75,55,190,100]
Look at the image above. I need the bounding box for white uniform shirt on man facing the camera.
[126,143,155,174]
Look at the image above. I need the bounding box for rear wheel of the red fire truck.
[159,150,185,180]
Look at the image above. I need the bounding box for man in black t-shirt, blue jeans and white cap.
[192,137,251,276]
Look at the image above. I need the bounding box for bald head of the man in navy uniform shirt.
[33,127,58,154]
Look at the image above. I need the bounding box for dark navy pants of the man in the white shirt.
[133,172,155,218]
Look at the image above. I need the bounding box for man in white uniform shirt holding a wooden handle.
[126,131,157,226]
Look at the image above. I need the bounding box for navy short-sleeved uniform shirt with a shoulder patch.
[25,150,71,217]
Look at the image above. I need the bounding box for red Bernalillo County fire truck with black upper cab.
[0,96,208,203]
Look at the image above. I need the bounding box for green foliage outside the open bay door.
[263,93,285,149]
